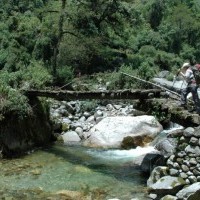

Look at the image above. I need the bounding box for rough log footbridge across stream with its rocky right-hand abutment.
[23,89,200,127]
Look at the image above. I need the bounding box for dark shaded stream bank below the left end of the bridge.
[0,98,56,157]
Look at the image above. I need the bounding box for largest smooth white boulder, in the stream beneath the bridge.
[84,115,163,148]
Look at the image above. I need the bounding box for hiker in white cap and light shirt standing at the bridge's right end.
[177,63,200,114]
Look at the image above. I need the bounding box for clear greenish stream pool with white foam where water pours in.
[0,144,151,200]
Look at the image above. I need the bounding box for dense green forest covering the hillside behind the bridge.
[0,0,200,119]
